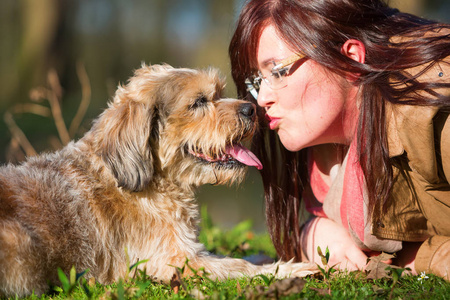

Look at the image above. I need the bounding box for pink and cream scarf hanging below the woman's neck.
[303,139,401,252]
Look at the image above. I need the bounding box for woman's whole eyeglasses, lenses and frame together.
[245,53,305,99]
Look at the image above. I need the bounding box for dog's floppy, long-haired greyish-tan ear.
[94,101,158,192]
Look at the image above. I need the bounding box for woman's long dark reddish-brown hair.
[229,0,450,260]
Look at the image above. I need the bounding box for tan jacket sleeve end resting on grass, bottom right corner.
[414,235,450,281]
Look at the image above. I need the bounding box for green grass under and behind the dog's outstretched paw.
[7,208,450,299]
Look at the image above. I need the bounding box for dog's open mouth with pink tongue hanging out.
[189,144,263,170]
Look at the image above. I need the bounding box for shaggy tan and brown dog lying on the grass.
[0,64,315,296]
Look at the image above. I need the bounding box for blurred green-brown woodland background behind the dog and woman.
[0,0,450,231]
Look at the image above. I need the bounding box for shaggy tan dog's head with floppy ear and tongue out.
[93,65,262,191]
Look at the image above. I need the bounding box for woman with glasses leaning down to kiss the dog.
[229,0,450,279]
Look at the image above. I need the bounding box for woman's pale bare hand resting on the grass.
[302,217,367,271]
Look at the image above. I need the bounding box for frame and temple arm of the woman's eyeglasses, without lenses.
[245,52,306,99]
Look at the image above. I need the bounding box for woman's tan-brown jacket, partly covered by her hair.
[372,52,450,280]
